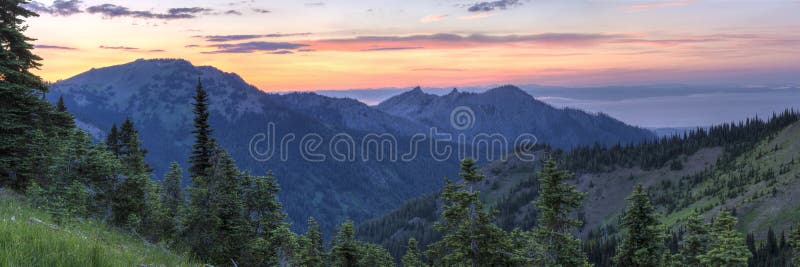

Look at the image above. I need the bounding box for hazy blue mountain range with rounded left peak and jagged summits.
[47,59,655,232]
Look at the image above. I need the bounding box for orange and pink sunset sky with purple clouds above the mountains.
[21,0,800,91]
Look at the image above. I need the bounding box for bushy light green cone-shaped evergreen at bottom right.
[699,210,752,267]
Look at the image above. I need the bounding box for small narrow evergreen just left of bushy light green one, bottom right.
[680,212,710,266]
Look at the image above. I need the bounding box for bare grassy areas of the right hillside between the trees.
[358,123,800,255]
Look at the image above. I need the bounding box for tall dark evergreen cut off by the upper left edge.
[0,0,53,190]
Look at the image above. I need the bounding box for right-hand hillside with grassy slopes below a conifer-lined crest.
[358,111,800,264]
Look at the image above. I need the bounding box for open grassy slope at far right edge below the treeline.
[664,120,800,234]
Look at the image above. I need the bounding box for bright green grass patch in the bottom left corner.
[0,188,200,267]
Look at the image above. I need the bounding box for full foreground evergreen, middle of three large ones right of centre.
[533,160,588,266]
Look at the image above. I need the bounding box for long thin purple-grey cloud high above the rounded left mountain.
[86,4,212,20]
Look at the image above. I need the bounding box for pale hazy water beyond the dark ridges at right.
[537,90,800,128]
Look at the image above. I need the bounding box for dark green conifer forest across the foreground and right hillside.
[0,0,800,266]
